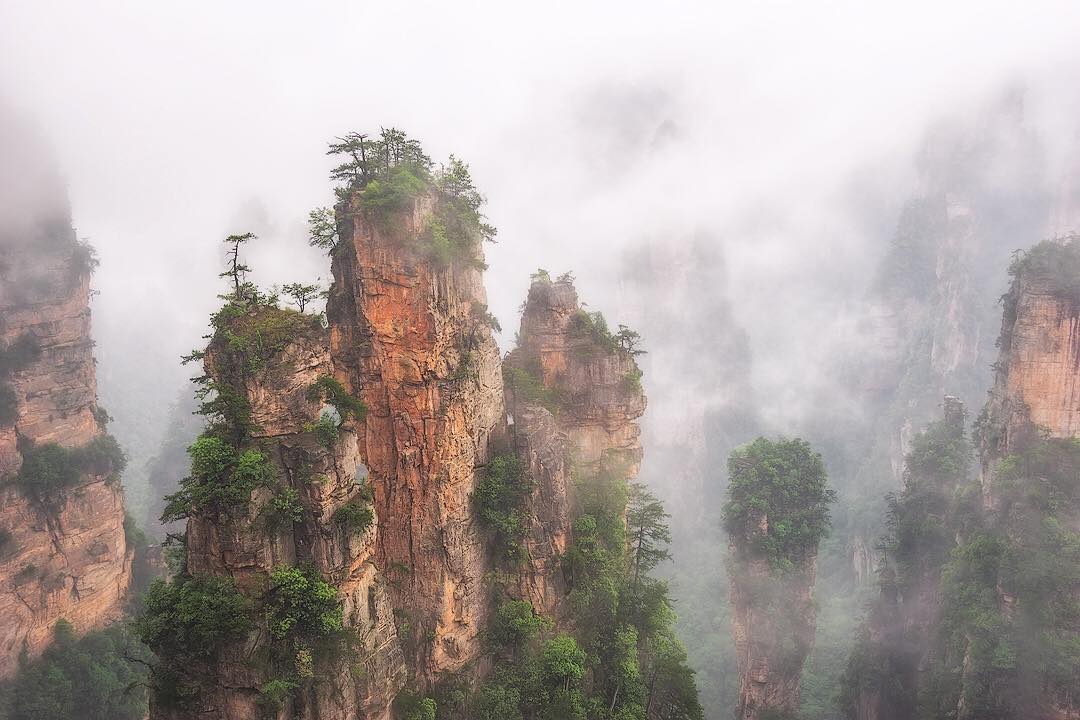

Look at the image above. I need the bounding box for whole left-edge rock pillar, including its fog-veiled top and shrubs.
[0,104,132,679]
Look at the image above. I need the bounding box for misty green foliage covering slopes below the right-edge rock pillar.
[841,410,1080,719]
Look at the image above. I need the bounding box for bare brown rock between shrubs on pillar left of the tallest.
[160,309,406,720]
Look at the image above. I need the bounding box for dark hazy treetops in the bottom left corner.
[0,620,149,720]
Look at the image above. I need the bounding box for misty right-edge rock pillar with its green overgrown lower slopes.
[845,239,1080,720]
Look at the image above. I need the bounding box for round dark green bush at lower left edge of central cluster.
[134,575,255,666]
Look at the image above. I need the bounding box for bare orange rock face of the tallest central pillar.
[327,195,503,681]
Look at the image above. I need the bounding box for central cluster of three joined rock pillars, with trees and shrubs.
[137,128,701,720]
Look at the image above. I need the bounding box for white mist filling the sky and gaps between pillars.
[0,0,1080,718]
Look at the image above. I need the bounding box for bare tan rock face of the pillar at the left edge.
[0,235,133,679]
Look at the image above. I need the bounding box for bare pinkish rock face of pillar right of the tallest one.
[504,277,645,617]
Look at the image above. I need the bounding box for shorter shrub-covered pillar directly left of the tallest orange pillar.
[139,304,406,720]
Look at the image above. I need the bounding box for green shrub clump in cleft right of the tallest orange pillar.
[472,453,532,563]
